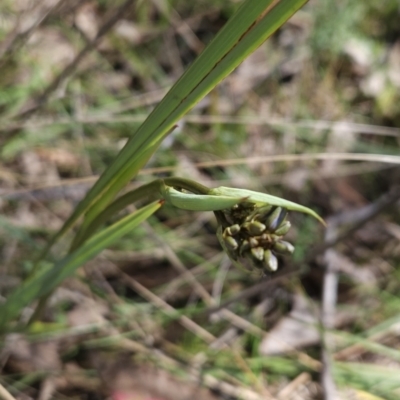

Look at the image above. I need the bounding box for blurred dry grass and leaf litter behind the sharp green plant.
[0,0,400,400]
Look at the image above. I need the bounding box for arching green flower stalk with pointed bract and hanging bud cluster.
[71,177,324,274]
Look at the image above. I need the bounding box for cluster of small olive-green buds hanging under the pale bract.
[222,202,294,273]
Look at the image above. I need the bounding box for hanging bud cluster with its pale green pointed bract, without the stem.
[162,178,324,274]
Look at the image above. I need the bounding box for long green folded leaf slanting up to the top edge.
[49,0,306,244]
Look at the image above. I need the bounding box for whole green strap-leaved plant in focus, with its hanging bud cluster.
[0,0,322,331]
